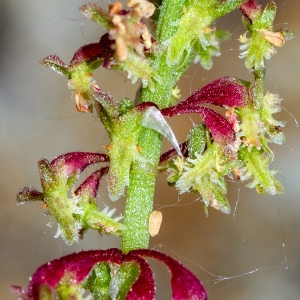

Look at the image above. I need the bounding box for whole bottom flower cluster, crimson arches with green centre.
[11,249,207,300]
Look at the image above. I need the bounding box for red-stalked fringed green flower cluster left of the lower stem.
[17,152,125,244]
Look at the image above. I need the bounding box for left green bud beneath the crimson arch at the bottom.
[82,262,111,300]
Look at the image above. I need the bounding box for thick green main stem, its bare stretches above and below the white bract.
[121,0,244,253]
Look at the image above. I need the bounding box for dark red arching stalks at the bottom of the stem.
[11,248,207,300]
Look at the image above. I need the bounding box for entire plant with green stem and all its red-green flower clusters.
[12,0,292,300]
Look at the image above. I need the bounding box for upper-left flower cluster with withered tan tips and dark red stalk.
[41,0,160,112]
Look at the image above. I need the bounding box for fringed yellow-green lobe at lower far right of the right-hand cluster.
[238,147,284,195]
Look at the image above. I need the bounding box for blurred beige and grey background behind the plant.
[0,0,300,300]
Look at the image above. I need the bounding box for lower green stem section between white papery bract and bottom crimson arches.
[121,129,162,253]
